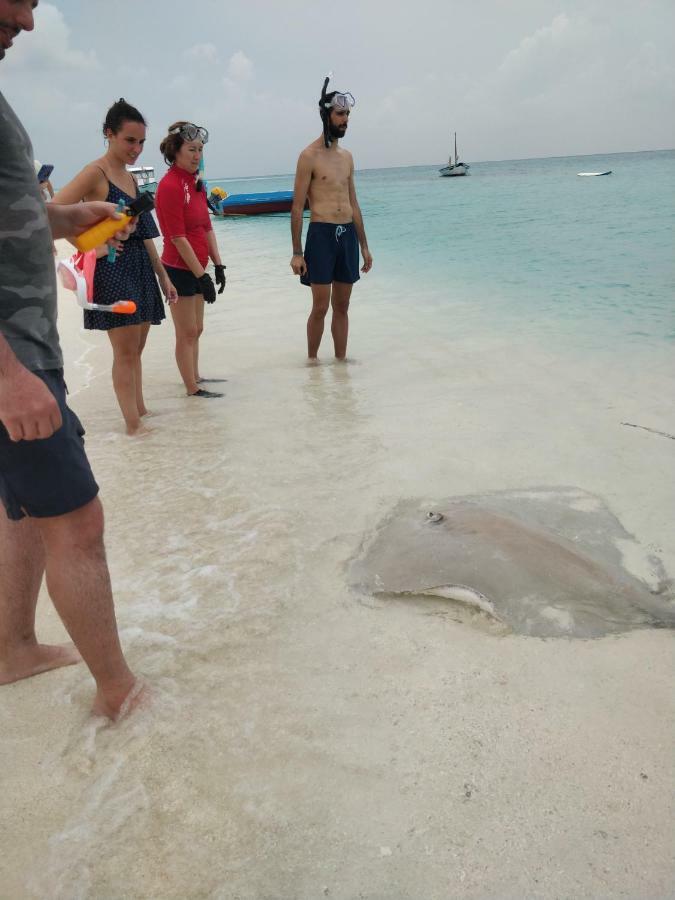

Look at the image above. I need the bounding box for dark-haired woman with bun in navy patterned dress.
[53,99,177,435]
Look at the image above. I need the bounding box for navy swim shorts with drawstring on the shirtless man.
[300,222,361,285]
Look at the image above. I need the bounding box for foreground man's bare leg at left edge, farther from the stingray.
[0,507,81,685]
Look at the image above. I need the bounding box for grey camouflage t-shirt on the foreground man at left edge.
[0,93,63,371]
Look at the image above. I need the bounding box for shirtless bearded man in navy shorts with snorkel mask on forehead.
[291,78,373,363]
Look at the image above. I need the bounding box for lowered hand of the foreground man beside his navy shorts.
[0,363,62,441]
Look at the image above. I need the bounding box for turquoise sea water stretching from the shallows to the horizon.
[209,150,675,350]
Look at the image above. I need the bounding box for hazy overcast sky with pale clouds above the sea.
[0,0,675,184]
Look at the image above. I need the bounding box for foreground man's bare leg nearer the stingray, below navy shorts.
[36,498,137,719]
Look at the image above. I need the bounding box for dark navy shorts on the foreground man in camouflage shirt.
[0,369,98,520]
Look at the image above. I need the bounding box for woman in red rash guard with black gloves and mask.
[155,122,225,398]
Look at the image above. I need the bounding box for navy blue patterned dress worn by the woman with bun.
[84,181,166,331]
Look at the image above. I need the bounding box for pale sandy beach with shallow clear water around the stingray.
[0,236,675,900]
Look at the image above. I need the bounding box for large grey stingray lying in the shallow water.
[351,487,675,638]
